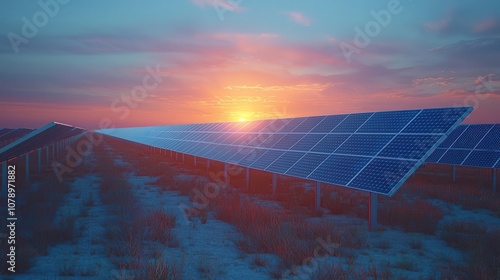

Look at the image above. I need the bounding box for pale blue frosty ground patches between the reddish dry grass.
[7,143,500,279]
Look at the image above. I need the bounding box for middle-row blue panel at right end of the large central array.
[379,135,443,159]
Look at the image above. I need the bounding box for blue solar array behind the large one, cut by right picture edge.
[427,124,500,168]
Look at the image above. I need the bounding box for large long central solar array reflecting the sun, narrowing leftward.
[97,107,472,195]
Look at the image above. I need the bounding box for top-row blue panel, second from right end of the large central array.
[358,111,418,133]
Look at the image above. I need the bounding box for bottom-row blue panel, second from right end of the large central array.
[307,155,370,186]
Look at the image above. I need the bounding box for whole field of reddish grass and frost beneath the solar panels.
[1,135,500,280]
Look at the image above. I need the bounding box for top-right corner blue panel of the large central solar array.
[403,107,470,134]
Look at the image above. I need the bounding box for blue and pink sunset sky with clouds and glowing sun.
[0,0,500,129]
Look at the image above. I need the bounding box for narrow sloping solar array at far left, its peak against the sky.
[0,122,85,162]
